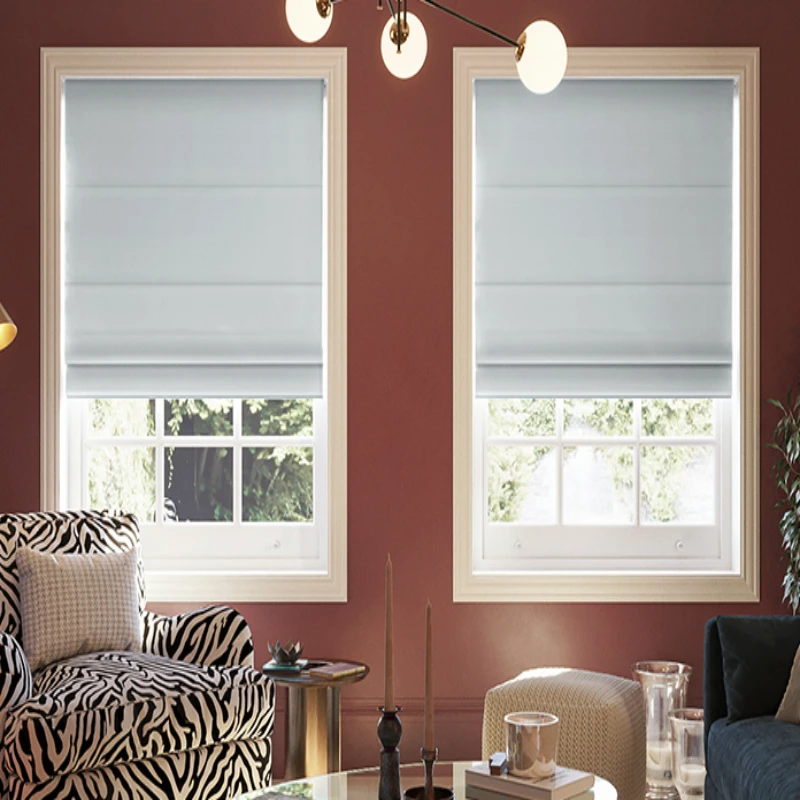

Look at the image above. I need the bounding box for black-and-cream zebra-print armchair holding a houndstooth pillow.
[0,511,275,800]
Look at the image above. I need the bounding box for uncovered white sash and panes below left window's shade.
[68,399,328,571]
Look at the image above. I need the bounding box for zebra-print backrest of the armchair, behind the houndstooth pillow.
[0,511,145,641]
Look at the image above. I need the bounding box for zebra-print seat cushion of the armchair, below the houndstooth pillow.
[4,652,274,783]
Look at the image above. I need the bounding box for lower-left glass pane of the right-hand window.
[487,447,556,524]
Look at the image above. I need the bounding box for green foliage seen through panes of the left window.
[89,399,314,522]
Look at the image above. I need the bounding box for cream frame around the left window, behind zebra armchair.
[41,48,347,602]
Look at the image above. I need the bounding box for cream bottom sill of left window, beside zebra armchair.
[145,566,347,603]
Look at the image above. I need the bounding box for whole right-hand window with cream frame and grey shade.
[453,49,758,601]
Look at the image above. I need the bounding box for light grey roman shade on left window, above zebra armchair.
[63,78,325,397]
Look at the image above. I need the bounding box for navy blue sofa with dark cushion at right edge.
[703,617,800,800]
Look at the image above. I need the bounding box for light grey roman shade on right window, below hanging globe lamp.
[475,79,735,397]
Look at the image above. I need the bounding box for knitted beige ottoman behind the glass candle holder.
[483,668,645,800]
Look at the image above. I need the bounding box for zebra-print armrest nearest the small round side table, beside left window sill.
[142,606,253,667]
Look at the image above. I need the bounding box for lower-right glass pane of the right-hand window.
[641,447,716,525]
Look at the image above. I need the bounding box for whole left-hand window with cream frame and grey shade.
[42,50,346,601]
